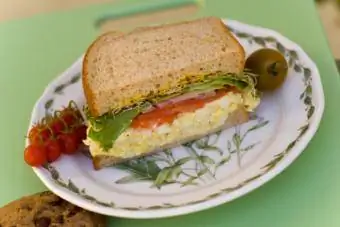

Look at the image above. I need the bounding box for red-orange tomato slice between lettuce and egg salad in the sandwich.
[131,89,231,129]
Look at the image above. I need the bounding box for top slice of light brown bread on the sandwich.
[82,17,245,117]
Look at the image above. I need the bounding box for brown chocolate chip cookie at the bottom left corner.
[0,191,106,227]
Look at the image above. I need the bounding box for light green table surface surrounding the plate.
[0,0,340,227]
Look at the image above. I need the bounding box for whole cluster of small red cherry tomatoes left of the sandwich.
[24,102,86,166]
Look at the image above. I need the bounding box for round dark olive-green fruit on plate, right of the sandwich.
[245,48,288,91]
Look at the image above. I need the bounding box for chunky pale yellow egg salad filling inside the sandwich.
[85,92,259,158]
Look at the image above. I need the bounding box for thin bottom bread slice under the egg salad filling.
[92,107,249,170]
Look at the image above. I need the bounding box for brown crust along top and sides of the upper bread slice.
[82,17,245,117]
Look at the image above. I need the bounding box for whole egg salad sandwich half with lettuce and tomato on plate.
[82,17,260,169]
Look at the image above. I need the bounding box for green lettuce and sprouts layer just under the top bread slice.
[86,72,256,150]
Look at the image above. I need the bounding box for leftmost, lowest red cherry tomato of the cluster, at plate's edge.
[24,144,47,167]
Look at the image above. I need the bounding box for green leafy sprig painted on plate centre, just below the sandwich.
[116,118,268,189]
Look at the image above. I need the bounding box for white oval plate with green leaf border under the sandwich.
[26,20,324,218]
